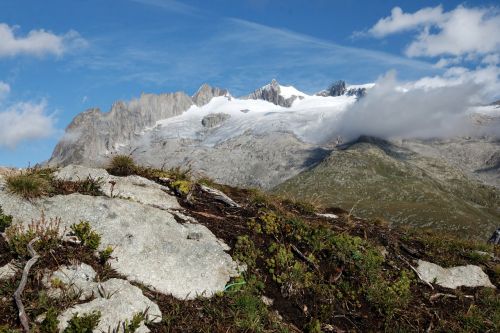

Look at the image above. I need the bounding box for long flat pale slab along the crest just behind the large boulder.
[54,165,181,209]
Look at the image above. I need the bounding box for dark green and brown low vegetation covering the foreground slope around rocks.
[0,161,500,333]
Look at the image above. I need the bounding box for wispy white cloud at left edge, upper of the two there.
[0,23,87,57]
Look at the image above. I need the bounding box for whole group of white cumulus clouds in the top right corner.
[368,6,500,57]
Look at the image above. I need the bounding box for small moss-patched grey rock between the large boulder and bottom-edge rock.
[42,263,99,300]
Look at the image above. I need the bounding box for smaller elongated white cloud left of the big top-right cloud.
[368,6,443,38]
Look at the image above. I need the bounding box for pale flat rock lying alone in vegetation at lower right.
[417,260,495,289]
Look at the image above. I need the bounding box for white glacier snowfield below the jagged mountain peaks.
[152,94,356,146]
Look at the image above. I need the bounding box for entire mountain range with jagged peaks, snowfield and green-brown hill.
[48,80,500,238]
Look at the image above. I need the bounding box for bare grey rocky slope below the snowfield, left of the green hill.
[127,132,329,189]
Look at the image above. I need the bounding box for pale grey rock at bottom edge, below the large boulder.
[58,279,161,333]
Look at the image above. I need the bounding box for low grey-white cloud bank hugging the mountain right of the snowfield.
[331,71,483,140]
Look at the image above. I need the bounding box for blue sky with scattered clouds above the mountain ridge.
[0,0,500,166]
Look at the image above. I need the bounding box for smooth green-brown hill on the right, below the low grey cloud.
[274,138,500,239]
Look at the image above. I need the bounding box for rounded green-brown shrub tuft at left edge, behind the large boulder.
[7,172,51,200]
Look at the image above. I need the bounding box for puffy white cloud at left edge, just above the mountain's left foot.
[0,101,55,148]
